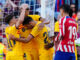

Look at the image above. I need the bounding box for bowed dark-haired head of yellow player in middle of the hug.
[23,16,35,29]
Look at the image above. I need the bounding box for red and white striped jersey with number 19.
[55,16,77,53]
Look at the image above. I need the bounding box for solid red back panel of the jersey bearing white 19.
[62,16,77,44]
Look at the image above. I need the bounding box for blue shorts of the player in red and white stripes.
[54,51,76,60]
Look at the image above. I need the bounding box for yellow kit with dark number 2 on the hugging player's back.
[31,22,53,60]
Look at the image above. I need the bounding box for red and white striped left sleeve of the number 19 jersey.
[55,17,66,41]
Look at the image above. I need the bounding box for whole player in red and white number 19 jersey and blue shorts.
[54,5,77,60]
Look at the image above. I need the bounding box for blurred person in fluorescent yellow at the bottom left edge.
[0,39,7,60]
